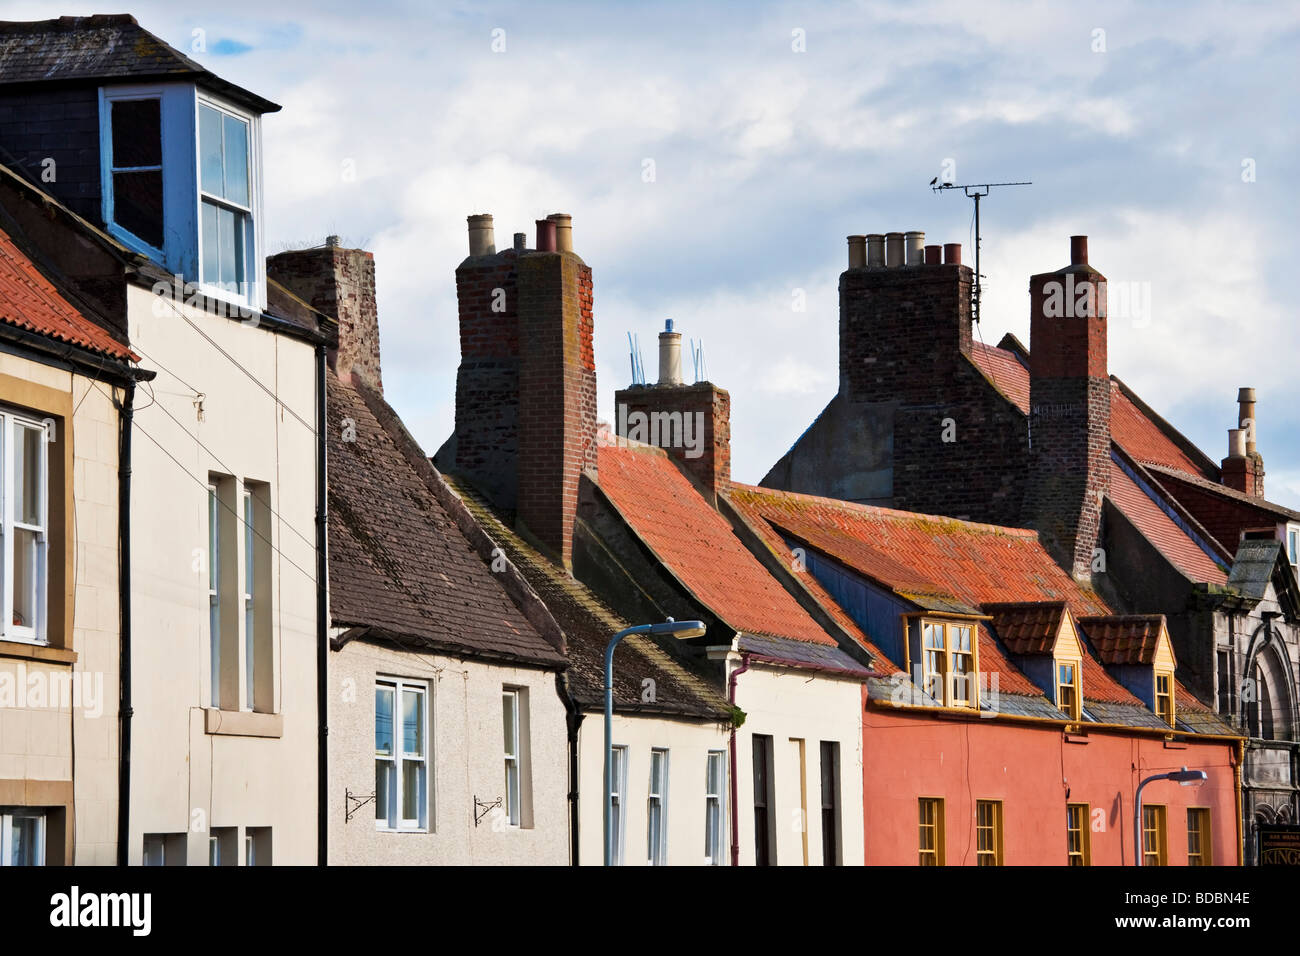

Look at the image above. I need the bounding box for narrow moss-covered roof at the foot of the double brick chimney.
[443,475,729,721]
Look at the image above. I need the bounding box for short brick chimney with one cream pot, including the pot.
[614,319,731,501]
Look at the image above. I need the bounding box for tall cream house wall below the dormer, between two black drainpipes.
[127,286,317,865]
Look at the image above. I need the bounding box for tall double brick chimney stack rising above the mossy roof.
[436,215,597,567]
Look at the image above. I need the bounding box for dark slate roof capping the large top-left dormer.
[0,13,280,113]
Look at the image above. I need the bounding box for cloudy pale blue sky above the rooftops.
[12,0,1300,507]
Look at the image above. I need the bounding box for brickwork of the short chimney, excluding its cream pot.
[614,382,731,494]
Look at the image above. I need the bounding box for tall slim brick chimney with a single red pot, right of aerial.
[1026,235,1110,578]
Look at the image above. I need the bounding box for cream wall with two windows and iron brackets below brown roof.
[328,641,568,866]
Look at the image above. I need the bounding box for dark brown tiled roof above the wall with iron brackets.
[326,372,564,667]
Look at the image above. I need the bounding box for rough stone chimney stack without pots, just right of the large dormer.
[267,235,384,393]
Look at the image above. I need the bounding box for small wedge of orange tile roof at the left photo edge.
[0,222,139,362]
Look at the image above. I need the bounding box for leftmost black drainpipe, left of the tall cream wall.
[117,380,135,866]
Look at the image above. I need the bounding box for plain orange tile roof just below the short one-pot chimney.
[598,445,836,645]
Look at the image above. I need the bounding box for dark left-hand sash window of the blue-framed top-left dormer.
[109,96,163,250]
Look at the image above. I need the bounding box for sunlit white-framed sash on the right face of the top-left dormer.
[199,101,252,295]
